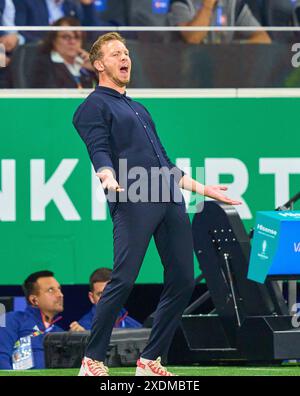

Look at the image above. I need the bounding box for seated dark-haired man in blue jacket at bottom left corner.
[0,271,64,370]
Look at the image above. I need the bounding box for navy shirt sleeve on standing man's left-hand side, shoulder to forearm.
[73,101,113,172]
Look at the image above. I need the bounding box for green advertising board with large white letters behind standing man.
[0,95,300,285]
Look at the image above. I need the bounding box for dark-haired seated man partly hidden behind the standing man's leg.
[70,268,142,331]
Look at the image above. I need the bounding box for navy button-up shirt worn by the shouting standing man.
[73,86,184,217]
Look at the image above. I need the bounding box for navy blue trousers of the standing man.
[86,202,194,361]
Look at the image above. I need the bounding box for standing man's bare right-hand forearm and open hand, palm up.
[179,175,242,205]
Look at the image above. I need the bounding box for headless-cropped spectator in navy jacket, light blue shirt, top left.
[14,0,103,41]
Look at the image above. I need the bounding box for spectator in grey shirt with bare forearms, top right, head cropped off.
[169,0,271,44]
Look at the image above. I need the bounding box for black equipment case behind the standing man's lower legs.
[44,329,151,368]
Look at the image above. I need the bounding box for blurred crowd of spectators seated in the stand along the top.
[0,0,300,88]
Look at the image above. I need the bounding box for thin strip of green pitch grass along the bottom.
[0,365,300,376]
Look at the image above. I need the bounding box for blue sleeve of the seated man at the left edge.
[0,312,19,370]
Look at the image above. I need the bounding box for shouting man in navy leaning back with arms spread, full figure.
[73,33,240,376]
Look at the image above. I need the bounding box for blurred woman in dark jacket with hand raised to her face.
[30,17,97,88]
